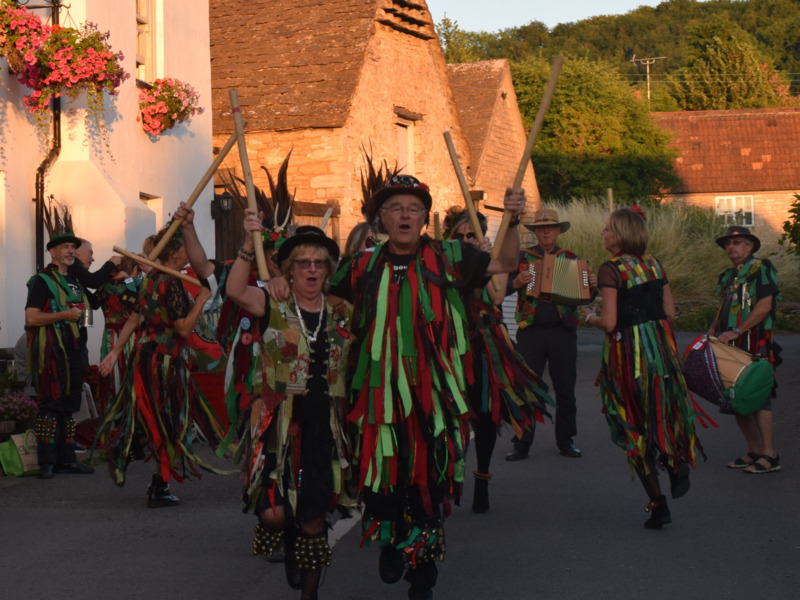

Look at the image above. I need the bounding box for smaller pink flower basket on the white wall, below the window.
[139,77,203,136]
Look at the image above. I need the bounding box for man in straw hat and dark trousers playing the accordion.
[506,209,581,461]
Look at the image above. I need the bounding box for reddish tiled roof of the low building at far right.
[654,108,800,194]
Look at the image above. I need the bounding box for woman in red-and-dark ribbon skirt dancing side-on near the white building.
[100,228,227,508]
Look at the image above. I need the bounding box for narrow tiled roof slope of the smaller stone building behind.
[447,60,508,176]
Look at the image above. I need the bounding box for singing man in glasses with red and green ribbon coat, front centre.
[324,175,525,599]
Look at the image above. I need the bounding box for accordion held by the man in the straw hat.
[527,254,591,304]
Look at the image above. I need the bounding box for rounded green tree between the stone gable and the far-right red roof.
[511,57,678,201]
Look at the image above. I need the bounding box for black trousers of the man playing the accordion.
[513,325,578,452]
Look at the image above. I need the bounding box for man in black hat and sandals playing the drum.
[708,225,781,474]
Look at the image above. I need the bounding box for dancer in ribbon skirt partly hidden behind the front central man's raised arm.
[444,207,552,513]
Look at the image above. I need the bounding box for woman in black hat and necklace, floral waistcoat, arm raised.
[227,209,352,600]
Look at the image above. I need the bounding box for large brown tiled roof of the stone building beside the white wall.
[210,0,434,133]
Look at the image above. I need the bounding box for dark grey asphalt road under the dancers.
[0,329,800,600]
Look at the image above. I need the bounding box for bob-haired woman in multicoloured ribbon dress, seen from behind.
[584,207,702,529]
